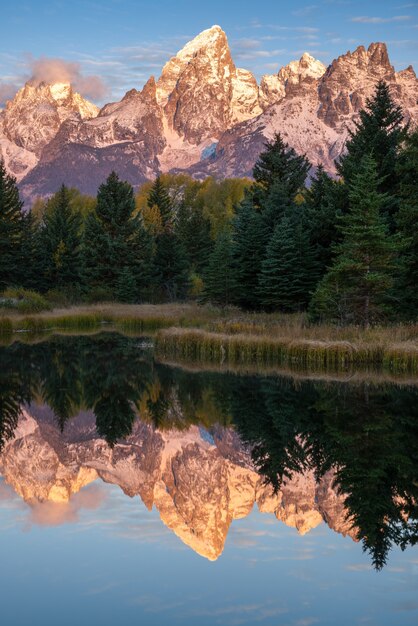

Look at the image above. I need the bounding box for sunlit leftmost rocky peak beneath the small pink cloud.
[0,81,99,180]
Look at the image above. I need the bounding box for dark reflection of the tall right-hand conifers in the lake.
[232,379,418,569]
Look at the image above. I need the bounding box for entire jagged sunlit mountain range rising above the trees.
[0,26,418,199]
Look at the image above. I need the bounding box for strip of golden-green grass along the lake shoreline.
[0,303,418,373]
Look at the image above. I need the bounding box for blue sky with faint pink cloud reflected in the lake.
[0,482,418,626]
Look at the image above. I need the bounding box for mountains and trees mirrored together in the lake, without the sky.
[0,334,418,567]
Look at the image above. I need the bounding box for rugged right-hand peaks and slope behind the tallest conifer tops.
[190,43,418,178]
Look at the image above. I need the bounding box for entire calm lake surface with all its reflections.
[0,333,418,626]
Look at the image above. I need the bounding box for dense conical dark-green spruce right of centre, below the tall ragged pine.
[258,215,318,312]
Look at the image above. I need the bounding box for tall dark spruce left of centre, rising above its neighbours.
[83,172,152,301]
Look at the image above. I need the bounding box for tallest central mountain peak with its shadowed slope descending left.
[18,26,262,196]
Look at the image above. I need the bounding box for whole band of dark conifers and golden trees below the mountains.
[0,82,418,327]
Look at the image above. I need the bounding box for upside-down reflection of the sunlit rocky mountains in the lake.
[0,406,356,560]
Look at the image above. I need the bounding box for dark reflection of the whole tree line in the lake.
[0,333,418,568]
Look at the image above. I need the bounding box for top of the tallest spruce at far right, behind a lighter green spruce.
[336,81,408,231]
